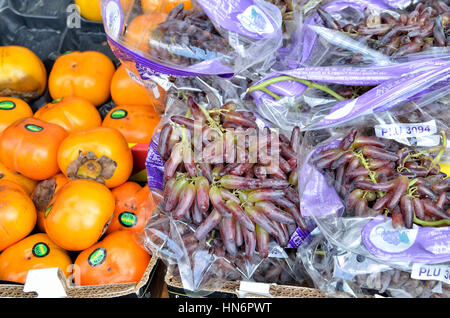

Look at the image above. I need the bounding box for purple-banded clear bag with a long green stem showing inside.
[247,55,449,129]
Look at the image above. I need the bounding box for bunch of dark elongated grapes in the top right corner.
[317,0,450,59]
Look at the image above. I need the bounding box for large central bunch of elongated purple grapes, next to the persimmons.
[158,97,306,259]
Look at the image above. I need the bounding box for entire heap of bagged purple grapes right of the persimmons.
[102,0,450,297]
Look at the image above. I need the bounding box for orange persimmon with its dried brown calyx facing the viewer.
[58,127,133,188]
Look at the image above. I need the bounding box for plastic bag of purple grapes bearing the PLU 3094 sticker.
[299,66,450,270]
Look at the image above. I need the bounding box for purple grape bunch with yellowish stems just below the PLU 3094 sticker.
[311,128,450,228]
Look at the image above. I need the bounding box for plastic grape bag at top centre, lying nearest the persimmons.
[102,0,282,80]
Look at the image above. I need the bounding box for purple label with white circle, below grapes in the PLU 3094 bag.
[362,215,450,263]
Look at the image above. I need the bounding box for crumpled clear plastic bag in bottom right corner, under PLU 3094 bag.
[297,229,450,298]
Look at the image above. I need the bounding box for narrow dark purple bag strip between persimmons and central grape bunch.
[145,132,164,191]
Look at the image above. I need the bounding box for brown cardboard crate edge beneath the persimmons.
[0,257,164,298]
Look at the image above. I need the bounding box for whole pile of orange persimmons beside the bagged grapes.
[0,46,158,285]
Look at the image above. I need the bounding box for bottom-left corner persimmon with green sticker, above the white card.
[0,233,72,284]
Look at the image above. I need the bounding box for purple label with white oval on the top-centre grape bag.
[197,0,281,40]
